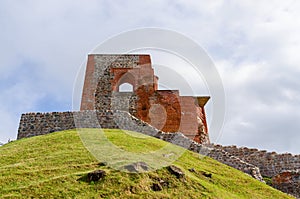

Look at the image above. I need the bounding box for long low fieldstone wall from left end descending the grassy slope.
[18,111,262,180]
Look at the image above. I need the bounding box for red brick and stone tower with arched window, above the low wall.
[81,54,209,143]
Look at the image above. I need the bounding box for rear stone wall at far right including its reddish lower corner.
[210,145,300,198]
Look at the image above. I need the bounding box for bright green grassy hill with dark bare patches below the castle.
[0,129,292,199]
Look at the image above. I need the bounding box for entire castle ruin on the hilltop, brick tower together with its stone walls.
[18,54,300,198]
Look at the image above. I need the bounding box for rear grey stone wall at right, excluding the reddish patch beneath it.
[213,145,300,177]
